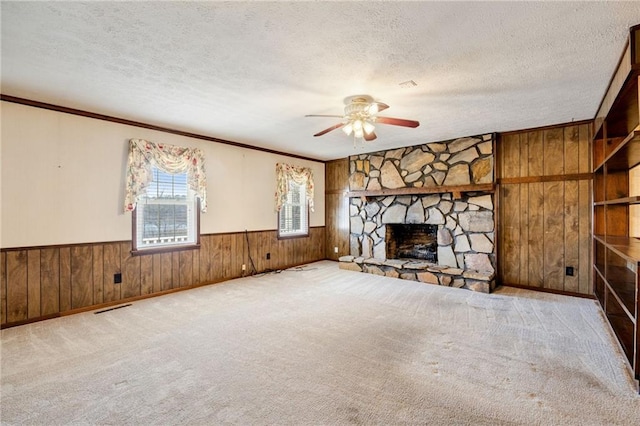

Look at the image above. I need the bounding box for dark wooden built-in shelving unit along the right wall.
[593,25,640,390]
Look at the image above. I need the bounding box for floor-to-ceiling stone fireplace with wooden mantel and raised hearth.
[340,134,495,292]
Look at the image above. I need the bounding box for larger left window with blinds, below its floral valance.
[133,167,200,251]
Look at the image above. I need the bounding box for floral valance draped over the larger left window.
[124,139,207,213]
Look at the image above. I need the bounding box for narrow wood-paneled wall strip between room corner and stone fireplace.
[324,158,349,260]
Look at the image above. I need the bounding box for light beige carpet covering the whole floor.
[1,261,640,425]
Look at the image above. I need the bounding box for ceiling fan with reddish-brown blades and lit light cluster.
[305,95,420,142]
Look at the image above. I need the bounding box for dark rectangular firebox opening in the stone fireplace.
[385,224,438,263]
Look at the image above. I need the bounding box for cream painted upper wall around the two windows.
[0,102,324,248]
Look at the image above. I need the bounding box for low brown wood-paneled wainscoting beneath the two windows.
[0,227,325,326]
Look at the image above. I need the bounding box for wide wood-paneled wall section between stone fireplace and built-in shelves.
[497,123,592,294]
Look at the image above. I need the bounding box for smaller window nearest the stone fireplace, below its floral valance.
[278,180,309,238]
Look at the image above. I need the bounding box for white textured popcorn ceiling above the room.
[1,1,640,159]
